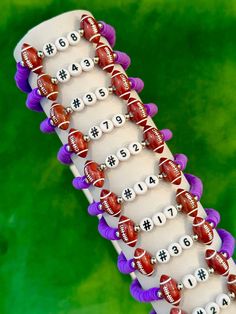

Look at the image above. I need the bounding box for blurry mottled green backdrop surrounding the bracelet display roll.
[0,0,236,314]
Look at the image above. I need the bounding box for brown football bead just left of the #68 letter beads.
[21,43,43,74]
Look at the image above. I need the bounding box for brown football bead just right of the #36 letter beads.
[193,217,214,245]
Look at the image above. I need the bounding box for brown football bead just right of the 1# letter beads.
[205,249,229,276]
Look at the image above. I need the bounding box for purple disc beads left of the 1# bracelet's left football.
[130,279,162,302]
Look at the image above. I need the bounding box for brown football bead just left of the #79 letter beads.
[68,129,88,158]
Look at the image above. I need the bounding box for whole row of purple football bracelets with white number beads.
[15,10,236,314]
